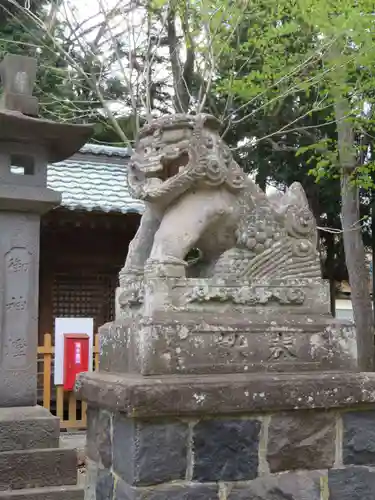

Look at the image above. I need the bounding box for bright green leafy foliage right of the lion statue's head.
[203,0,375,279]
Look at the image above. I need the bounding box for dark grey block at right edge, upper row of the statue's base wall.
[342,411,375,465]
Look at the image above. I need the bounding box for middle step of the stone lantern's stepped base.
[0,448,77,491]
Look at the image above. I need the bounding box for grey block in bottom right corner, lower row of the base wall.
[328,467,375,500]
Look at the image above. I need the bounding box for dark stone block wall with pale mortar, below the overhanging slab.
[86,407,375,500]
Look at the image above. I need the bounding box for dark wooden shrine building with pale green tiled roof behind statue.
[39,144,143,343]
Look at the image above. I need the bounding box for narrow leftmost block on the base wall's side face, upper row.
[86,406,112,469]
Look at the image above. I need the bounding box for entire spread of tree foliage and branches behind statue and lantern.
[0,0,375,278]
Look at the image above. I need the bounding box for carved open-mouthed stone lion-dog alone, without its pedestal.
[120,115,320,300]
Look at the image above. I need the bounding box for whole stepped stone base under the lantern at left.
[0,406,83,500]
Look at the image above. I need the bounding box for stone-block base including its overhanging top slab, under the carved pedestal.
[81,373,375,500]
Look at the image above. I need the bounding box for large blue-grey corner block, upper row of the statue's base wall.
[113,413,188,485]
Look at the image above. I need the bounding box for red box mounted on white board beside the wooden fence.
[64,333,90,391]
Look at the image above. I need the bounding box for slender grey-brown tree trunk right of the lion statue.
[335,96,374,371]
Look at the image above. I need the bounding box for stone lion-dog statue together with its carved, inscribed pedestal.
[100,115,358,375]
